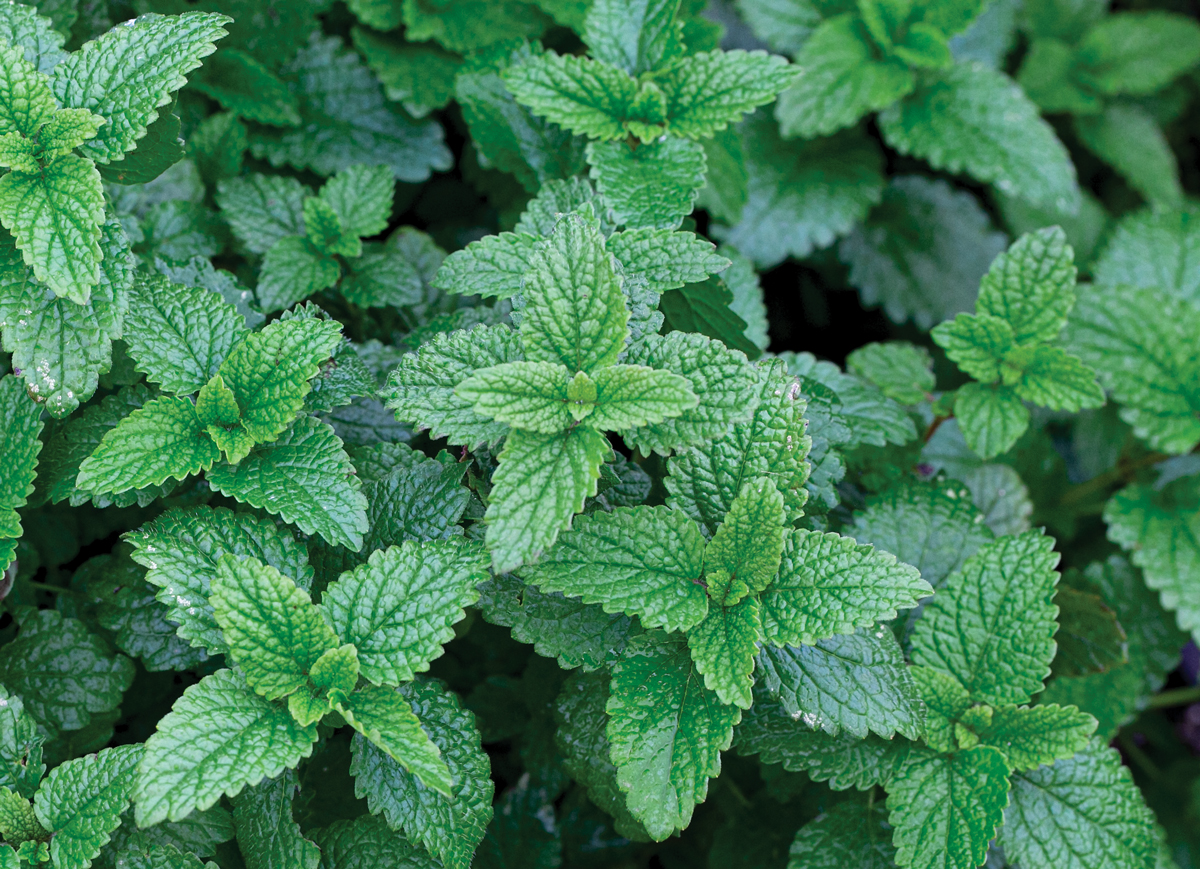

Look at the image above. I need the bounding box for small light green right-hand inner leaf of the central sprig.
[586,365,700,431]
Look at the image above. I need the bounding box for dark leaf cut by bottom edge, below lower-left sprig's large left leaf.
[232,769,320,869]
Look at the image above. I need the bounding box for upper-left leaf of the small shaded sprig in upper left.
[216,174,308,253]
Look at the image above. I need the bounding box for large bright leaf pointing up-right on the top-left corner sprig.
[52,12,233,163]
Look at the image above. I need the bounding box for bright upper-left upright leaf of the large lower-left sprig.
[209,555,337,700]
